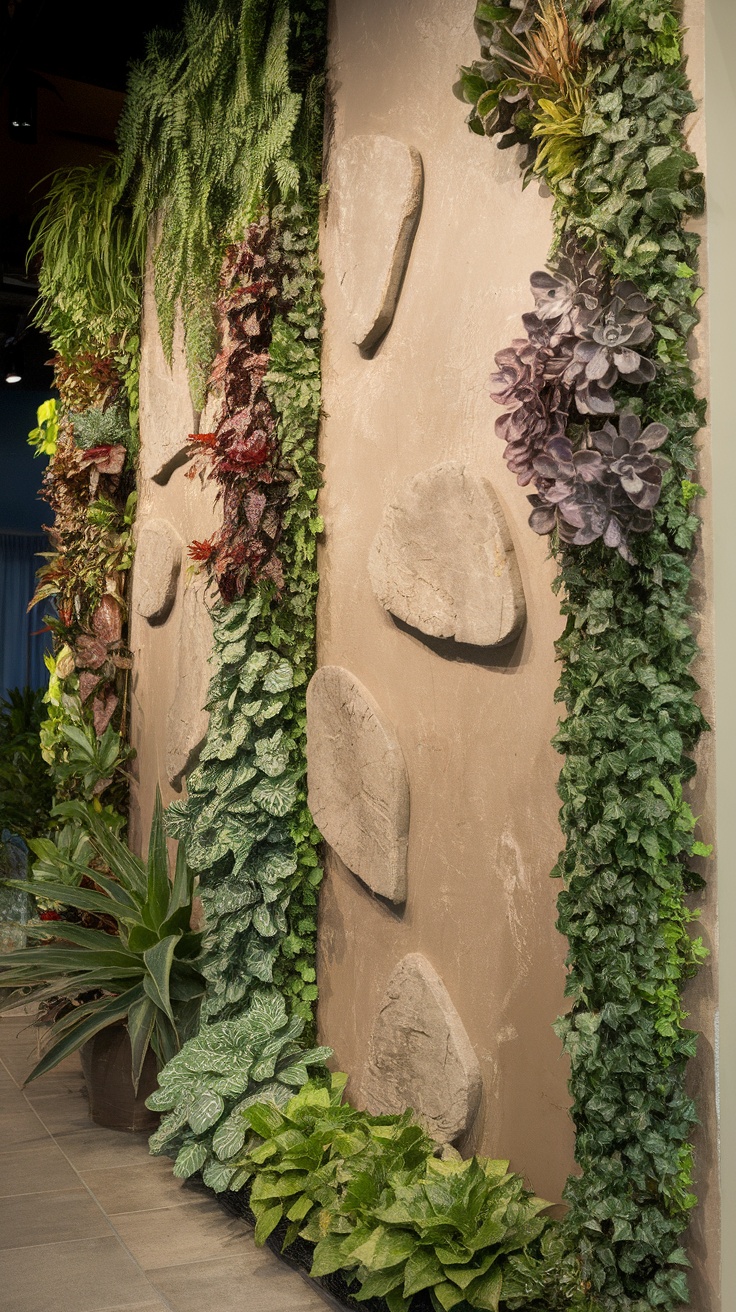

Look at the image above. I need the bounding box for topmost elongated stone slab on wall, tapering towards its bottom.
[329,135,422,349]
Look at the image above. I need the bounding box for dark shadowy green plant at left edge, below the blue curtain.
[0,687,52,842]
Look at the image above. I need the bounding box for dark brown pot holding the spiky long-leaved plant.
[80,1022,159,1130]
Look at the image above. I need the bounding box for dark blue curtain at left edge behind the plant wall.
[0,533,51,697]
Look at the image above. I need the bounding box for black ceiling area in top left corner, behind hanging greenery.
[0,0,184,392]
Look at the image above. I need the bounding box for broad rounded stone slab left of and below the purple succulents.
[369,461,526,647]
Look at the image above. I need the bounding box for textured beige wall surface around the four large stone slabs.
[317,0,719,1291]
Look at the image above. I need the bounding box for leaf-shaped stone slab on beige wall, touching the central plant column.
[307,665,409,903]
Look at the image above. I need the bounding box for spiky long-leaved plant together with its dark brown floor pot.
[0,794,205,1130]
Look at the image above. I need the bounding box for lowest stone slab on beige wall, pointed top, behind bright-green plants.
[361,953,481,1143]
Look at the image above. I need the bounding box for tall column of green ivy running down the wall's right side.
[462,0,710,1312]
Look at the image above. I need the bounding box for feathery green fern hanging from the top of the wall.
[119,0,325,407]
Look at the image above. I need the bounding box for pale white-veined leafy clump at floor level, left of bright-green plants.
[147,989,331,1191]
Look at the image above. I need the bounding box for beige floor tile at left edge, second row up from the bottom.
[0,1187,113,1263]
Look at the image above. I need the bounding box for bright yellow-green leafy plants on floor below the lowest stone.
[207,1076,550,1312]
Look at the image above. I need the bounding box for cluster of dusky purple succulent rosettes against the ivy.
[491,241,668,562]
